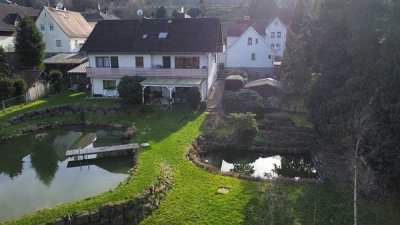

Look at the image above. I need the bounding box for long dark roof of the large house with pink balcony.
[81,18,222,53]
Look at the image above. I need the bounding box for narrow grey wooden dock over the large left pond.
[65,143,140,157]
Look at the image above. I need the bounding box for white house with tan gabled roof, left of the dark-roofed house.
[36,6,93,54]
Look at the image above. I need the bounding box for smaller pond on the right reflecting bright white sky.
[205,151,317,178]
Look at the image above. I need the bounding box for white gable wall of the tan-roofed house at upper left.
[36,10,79,53]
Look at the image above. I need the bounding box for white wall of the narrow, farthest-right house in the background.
[265,19,287,57]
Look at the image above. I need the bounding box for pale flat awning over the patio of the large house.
[140,78,204,87]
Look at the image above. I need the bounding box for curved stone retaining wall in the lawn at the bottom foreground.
[48,164,173,225]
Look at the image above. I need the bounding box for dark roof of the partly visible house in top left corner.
[0,3,39,34]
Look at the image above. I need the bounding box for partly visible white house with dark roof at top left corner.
[0,3,39,52]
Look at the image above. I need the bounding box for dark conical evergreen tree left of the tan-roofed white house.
[15,17,45,69]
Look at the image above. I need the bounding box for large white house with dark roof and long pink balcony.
[81,18,222,101]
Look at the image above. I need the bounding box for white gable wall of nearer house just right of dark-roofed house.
[226,27,274,68]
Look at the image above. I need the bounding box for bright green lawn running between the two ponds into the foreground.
[0,94,400,225]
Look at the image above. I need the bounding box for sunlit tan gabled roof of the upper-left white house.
[43,6,92,38]
